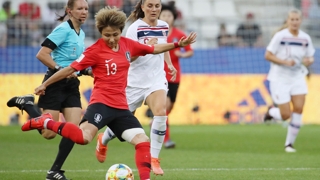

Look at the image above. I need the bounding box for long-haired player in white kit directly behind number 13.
[97,0,177,175]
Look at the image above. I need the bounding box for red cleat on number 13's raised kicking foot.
[21,113,52,131]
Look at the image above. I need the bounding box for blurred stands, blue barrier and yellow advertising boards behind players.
[0,0,320,125]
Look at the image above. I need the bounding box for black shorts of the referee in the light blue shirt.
[38,70,81,111]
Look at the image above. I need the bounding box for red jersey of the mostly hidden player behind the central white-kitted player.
[164,27,192,83]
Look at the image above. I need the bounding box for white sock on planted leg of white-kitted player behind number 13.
[150,116,167,158]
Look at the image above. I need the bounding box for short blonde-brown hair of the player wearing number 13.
[95,6,127,33]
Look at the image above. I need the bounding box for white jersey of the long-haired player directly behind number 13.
[126,19,169,88]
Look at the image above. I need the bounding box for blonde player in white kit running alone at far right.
[265,10,315,152]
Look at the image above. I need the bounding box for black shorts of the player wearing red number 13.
[80,103,142,141]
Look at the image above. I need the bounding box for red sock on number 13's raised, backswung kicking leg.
[47,121,84,145]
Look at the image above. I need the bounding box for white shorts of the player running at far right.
[270,78,308,104]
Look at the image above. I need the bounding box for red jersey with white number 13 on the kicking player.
[70,37,154,109]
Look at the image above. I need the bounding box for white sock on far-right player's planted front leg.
[285,113,302,146]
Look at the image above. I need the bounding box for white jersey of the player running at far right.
[267,29,315,82]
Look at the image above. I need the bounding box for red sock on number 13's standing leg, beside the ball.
[135,142,151,180]
